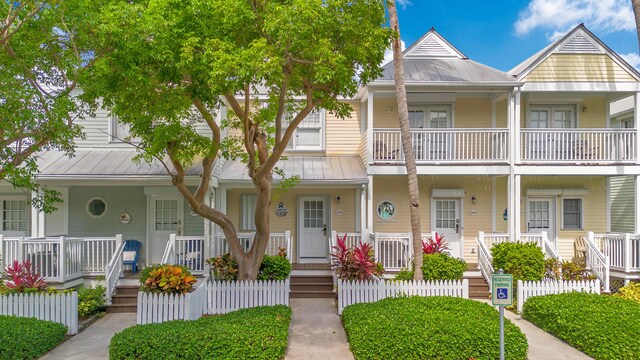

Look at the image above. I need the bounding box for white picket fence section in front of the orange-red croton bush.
[137,281,208,325]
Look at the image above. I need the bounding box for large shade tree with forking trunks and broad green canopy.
[83,0,391,280]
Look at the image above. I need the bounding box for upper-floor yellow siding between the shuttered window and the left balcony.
[325,102,364,156]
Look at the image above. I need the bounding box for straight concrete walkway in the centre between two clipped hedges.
[285,298,353,360]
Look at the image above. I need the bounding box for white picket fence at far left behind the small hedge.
[0,291,78,335]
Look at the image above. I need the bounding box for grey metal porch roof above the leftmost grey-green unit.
[38,149,201,177]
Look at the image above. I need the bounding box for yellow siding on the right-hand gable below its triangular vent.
[524,54,636,82]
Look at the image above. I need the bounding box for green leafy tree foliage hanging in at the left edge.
[0,0,99,212]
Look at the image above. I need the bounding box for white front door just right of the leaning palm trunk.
[431,199,462,258]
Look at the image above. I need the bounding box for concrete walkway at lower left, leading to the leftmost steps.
[40,313,136,360]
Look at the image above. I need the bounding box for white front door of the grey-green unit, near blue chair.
[149,196,184,264]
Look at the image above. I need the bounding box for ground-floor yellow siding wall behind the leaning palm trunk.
[372,176,491,263]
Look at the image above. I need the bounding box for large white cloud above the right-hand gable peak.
[514,0,636,41]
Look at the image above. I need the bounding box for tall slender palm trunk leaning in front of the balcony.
[387,0,423,280]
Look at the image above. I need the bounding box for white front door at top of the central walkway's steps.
[298,196,328,262]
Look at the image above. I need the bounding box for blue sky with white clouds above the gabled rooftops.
[396,0,640,71]
